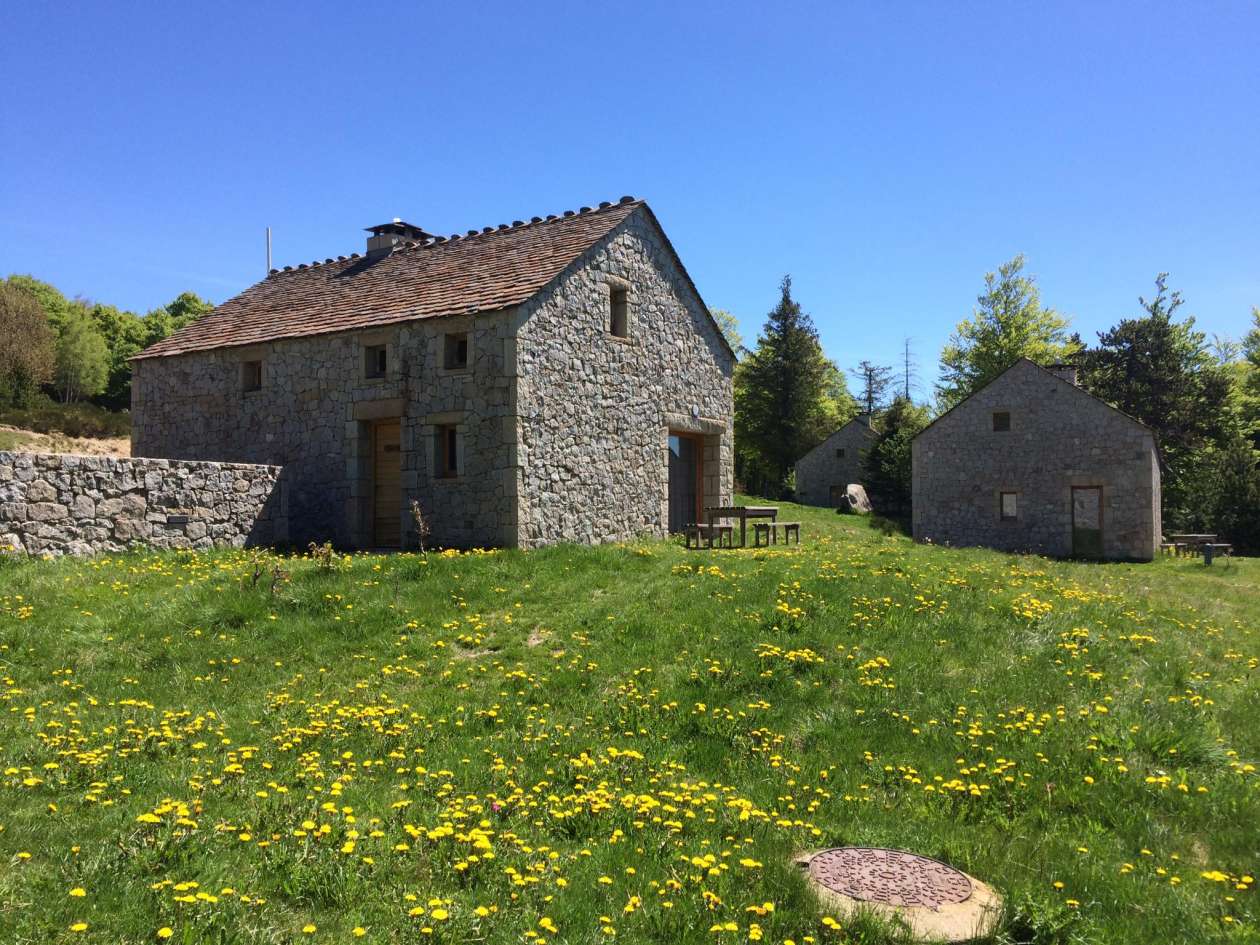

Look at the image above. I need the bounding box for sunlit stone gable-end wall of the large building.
[517,209,735,547]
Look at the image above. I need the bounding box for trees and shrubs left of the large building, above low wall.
[0,276,214,411]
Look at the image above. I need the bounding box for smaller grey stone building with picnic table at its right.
[912,359,1160,561]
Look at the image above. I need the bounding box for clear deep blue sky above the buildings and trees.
[0,1,1260,393]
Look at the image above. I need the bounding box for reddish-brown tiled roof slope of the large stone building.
[136,197,646,359]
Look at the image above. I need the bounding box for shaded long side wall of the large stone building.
[132,312,517,547]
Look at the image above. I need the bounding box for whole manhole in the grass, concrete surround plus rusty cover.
[796,847,1002,942]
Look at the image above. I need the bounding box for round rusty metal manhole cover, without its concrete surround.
[809,847,971,910]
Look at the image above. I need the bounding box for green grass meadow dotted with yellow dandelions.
[0,509,1260,945]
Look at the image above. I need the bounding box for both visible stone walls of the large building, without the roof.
[132,209,733,547]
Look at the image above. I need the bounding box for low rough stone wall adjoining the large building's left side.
[0,451,289,554]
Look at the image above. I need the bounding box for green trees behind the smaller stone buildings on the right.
[719,256,1260,552]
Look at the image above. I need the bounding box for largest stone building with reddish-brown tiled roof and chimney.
[132,198,735,548]
